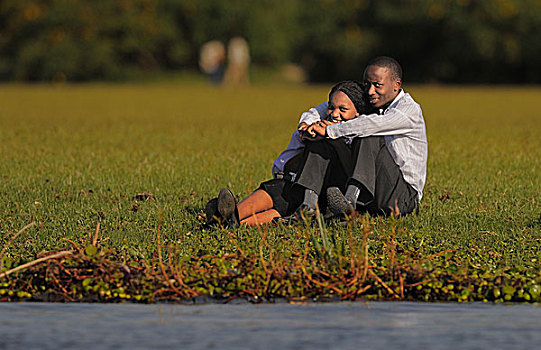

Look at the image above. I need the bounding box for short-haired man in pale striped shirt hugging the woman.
[284,56,428,217]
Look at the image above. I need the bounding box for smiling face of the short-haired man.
[364,66,401,108]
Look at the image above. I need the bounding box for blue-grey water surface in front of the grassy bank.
[0,302,541,349]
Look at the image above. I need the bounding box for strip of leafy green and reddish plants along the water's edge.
[0,216,541,303]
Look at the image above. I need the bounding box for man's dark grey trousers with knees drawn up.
[295,136,418,215]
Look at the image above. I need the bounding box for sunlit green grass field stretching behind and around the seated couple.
[0,82,541,304]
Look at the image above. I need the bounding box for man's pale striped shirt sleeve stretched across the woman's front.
[327,108,416,139]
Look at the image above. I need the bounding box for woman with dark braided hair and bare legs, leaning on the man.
[205,80,371,228]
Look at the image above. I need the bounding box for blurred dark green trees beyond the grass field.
[0,0,541,83]
